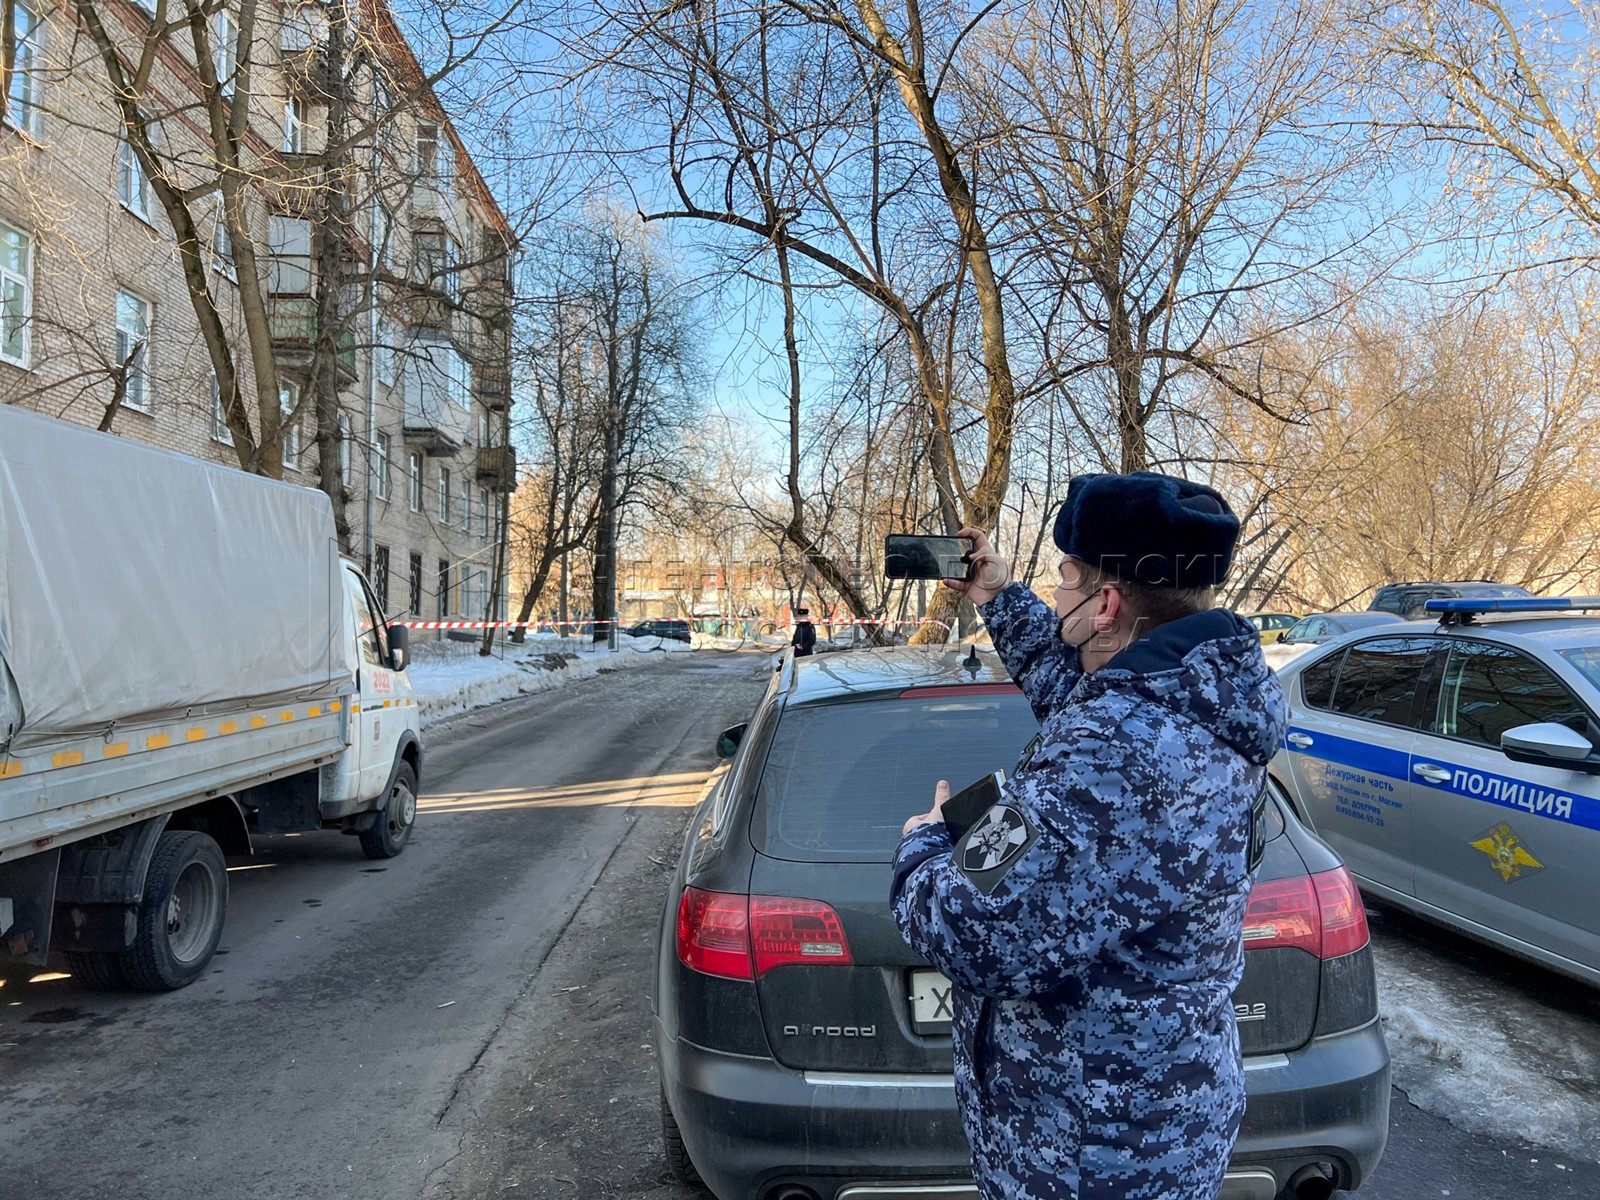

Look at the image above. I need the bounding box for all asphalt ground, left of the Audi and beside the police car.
[0,653,1600,1200]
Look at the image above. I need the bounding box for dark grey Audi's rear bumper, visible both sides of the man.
[656,1021,1389,1200]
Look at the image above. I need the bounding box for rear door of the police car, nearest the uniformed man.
[1285,637,1434,894]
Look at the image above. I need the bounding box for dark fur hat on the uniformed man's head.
[1054,470,1238,587]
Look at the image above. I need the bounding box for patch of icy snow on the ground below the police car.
[1374,947,1600,1160]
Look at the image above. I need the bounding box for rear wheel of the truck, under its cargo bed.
[123,830,227,992]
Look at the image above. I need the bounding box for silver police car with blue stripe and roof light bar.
[1270,597,1600,982]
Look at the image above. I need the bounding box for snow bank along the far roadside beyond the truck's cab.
[406,634,690,726]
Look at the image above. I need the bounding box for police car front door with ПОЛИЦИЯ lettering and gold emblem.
[1411,637,1600,966]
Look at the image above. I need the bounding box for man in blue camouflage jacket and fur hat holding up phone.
[893,474,1286,1200]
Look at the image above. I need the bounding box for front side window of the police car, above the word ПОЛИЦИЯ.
[1437,642,1589,746]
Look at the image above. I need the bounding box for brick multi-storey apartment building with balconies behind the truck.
[0,0,517,619]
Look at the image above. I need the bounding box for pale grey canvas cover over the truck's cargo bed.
[0,405,355,752]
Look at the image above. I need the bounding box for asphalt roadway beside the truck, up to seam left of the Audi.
[0,653,770,1200]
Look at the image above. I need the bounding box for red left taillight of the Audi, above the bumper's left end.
[678,888,853,979]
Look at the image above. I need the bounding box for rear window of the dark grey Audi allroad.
[750,690,1038,862]
